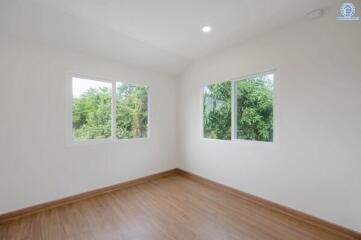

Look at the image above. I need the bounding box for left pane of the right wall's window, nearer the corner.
[203,82,232,140]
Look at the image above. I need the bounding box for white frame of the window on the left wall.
[66,73,150,146]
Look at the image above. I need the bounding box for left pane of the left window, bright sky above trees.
[72,78,112,140]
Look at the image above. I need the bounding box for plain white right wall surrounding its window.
[177,4,361,231]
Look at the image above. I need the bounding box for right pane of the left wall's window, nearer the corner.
[116,83,148,139]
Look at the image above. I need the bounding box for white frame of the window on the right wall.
[200,69,279,145]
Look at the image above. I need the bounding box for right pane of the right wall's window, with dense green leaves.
[237,74,274,142]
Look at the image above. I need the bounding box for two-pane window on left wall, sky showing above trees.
[72,77,148,140]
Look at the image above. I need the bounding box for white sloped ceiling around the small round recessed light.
[0,0,340,75]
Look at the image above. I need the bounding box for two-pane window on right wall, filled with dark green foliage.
[203,73,274,142]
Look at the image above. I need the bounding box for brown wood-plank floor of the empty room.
[0,174,351,240]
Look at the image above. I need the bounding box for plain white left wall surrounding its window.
[0,36,176,214]
